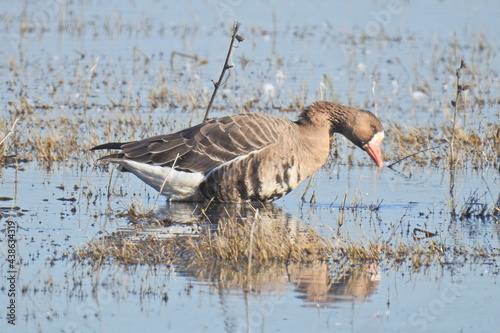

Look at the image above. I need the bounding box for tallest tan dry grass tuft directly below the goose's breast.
[190,211,333,265]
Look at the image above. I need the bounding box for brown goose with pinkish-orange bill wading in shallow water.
[92,101,384,202]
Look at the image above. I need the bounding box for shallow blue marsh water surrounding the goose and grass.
[0,1,500,332]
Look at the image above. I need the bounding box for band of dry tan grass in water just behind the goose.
[1,94,500,169]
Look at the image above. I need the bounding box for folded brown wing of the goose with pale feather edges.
[92,113,293,173]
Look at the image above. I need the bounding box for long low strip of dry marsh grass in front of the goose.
[71,204,499,275]
